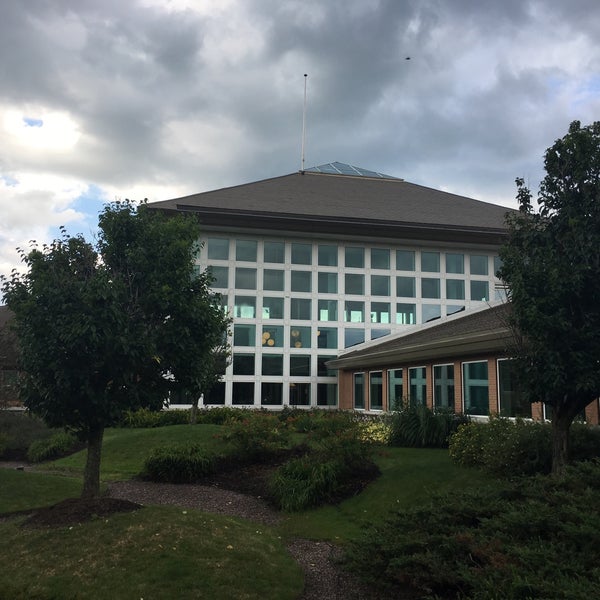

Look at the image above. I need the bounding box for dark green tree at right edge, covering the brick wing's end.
[500,121,600,475]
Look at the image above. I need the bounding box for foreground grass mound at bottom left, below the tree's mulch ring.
[0,507,303,600]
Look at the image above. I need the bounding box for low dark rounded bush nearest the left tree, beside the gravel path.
[143,444,219,483]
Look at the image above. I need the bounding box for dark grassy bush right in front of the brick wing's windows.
[390,403,468,448]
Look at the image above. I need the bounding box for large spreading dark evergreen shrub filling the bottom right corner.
[346,461,600,600]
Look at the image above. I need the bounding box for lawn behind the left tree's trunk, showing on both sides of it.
[45,425,224,481]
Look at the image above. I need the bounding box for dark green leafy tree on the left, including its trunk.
[2,201,228,497]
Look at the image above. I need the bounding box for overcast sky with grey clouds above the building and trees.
[0,0,600,273]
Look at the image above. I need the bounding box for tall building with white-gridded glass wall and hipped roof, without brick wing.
[150,163,508,408]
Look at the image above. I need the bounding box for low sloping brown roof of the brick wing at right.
[327,303,513,369]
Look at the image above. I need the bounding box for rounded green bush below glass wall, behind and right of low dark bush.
[222,412,290,462]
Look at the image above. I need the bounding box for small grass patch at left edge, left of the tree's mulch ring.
[0,469,81,514]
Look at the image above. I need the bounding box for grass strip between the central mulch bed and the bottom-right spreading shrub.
[281,448,500,543]
